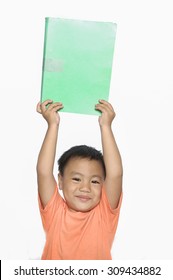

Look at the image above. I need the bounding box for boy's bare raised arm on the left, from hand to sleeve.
[37,100,63,207]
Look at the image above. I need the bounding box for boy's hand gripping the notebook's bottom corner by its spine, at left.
[37,100,63,125]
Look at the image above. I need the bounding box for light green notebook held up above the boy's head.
[41,18,116,115]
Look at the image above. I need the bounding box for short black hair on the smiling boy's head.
[58,145,106,178]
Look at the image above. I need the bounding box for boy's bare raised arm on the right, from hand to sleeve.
[95,100,123,209]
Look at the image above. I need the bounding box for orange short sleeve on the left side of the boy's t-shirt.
[38,187,63,233]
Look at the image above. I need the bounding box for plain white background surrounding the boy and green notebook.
[0,0,173,260]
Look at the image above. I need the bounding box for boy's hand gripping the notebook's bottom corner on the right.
[95,100,115,126]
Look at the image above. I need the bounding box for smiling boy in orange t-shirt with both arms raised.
[37,100,123,260]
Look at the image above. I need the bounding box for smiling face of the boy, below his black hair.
[59,158,104,212]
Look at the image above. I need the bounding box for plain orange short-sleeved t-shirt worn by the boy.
[39,188,122,260]
